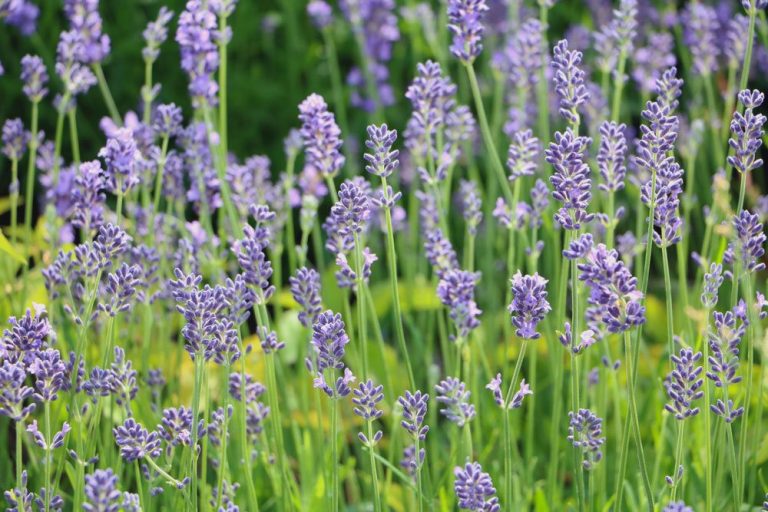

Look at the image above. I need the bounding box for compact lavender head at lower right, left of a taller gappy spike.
[664,348,704,420]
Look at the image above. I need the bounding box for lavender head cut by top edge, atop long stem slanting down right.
[448,0,488,64]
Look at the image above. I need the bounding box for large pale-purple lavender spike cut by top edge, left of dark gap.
[176,0,219,106]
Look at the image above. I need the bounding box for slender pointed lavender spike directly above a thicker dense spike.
[552,39,589,124]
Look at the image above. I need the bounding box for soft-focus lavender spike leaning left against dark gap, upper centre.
[299,94,344,178]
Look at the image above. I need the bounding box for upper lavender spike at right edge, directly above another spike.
[728,89,766,173]
